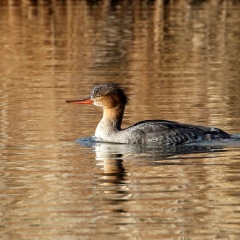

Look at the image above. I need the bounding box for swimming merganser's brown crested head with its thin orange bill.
[66,83,128,109]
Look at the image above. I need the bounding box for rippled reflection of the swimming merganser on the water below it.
[77,138,227,198]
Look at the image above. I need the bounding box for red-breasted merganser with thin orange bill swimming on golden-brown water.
[66,83,231,145]
